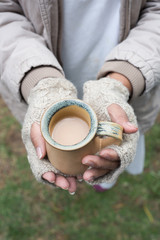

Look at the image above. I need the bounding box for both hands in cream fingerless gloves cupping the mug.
[22,76,138,194]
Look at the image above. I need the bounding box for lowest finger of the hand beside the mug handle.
[83,168,111,181]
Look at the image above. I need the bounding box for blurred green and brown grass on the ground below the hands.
[0,97,160,240]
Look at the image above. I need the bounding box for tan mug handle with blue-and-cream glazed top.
[94,121,123,152]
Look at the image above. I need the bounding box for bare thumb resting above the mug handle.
[107,103,138,133]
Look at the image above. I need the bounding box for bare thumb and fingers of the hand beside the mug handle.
[82,104,138,181]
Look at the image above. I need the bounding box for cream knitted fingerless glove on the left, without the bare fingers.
[22,78,77,185]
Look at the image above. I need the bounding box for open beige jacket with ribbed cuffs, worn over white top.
[0,0,160,132]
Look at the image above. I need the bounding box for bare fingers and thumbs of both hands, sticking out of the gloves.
[31,104,137,194]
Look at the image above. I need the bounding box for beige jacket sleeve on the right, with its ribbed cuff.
[98,0,160,97]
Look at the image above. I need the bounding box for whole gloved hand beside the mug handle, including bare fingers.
[82,78,138,185]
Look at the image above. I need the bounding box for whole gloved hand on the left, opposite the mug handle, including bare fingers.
[22,78,77,191]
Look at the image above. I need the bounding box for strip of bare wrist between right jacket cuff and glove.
[107,72,133,96]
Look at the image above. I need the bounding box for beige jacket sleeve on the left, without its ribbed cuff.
[0,0,63,122]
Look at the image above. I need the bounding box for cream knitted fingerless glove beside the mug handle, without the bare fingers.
[83,78,138,185]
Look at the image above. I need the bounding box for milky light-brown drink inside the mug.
[52,117,89,145]
